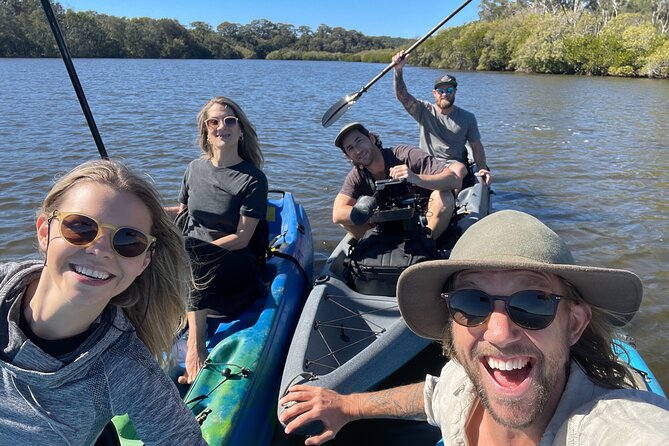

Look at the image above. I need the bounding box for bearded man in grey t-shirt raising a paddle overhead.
[393,51,492,185]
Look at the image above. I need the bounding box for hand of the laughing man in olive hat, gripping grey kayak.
[279,385,356,445]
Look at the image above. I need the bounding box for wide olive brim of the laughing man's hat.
[397,258,643,340]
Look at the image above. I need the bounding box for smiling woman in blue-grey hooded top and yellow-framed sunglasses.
[0,161,205,445]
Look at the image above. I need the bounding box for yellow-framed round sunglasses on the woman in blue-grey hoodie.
[49,211,156,257]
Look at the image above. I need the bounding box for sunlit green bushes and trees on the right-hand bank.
[412,0,669,78]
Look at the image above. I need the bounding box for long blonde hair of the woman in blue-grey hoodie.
[41,160,191,365]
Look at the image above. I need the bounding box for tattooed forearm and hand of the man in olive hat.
[279,383,427,445]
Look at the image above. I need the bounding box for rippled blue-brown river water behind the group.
[0,59,669,390]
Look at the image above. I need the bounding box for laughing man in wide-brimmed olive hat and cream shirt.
[281,210,669,446]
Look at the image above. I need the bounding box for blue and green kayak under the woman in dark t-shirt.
[113,191,313,445]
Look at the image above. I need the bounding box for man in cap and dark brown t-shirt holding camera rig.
[332,122,462,240]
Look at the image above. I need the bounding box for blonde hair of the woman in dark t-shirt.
[197,96,264,169]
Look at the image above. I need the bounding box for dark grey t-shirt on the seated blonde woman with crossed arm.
[179,158,267,242]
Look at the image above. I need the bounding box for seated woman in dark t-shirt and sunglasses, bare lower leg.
[169,96,268,384]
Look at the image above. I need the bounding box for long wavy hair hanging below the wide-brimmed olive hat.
[442,273,638,389]
